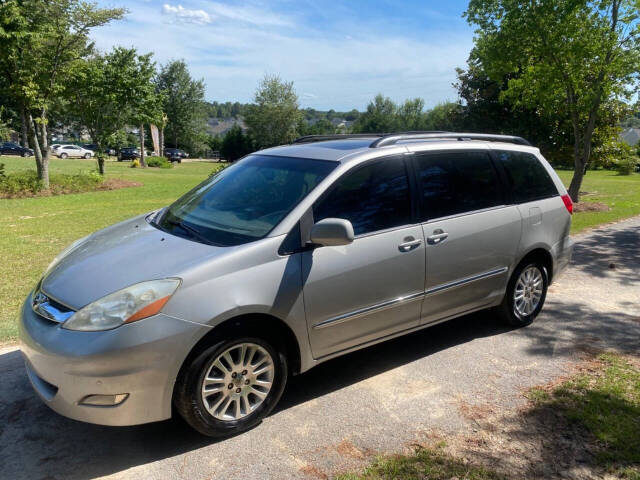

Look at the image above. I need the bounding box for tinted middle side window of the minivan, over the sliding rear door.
[417,152,504,220]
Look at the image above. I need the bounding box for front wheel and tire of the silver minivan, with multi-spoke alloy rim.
[174,337,288,438]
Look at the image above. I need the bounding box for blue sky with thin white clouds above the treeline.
[92,0,473,110]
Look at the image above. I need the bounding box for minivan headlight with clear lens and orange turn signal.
[62,278,180,332]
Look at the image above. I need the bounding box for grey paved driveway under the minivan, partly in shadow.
[0,217,640,480]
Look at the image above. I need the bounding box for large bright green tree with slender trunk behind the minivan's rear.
[465,0,640,202]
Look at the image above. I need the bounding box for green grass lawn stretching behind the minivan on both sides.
[0,156,640,342]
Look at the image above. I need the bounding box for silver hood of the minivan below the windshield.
[42,214,228,309]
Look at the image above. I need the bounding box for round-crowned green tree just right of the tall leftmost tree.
[67,47,159,174]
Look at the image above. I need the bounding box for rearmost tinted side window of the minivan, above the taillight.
[496,151,558,203]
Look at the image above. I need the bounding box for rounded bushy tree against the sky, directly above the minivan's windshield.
[245,75,303,148]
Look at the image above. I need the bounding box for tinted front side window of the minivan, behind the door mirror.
[313,158,411,235]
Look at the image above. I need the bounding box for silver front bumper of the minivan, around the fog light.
[18,295,209,425]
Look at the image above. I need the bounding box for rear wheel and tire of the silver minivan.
[497,260,549,327]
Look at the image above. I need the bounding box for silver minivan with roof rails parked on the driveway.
[19,133,572,436]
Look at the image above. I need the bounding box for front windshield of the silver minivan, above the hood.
[154,155,338,246]
